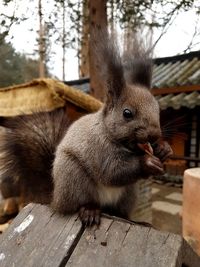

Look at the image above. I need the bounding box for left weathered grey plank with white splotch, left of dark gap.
[0,204,83,267]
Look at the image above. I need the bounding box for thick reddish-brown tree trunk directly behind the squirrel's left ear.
[89,0,107,101]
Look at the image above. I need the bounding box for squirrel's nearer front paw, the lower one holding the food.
[144,155,164,175]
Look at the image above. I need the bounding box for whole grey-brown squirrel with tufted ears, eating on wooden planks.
[0,30,172,225]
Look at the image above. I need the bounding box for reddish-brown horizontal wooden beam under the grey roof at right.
[151,85,200,96]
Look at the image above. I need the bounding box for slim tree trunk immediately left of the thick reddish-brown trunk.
[79,0,89,78]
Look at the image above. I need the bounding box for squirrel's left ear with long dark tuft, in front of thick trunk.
[91,28,125,104]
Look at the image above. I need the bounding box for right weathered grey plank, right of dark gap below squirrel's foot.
[66,219,200,267]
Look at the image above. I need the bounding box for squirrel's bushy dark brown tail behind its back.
[0,109,69,203]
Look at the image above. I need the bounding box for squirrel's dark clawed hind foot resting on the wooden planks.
[79,204,101,226]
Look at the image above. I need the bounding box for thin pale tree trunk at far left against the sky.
[38,0,45,78]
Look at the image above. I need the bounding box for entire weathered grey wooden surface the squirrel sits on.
[0,204,200,267]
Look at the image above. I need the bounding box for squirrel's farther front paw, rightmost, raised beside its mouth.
[153,141,173,162]
